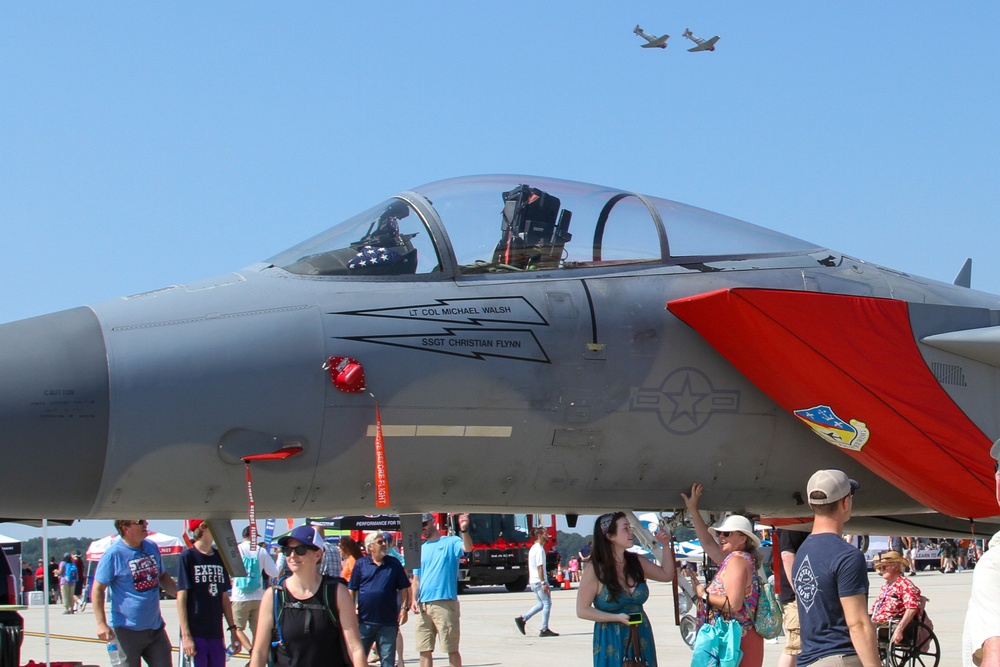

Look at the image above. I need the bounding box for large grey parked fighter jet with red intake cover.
[0,175,1000,534]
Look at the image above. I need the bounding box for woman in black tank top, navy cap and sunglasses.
[250,526,367,667]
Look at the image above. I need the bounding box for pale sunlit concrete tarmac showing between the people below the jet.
[13,571,972,667]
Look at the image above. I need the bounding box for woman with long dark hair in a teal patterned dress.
[576,512,674,667]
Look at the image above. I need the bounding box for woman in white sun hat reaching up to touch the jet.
[681,484,764,667]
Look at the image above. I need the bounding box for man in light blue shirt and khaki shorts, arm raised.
[410,514,472,667]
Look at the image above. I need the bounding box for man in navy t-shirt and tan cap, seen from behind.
[792,469,882,667]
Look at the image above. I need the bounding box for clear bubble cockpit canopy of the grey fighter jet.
[269,176,818,277]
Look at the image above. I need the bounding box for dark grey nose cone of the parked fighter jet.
[0,308,109,519]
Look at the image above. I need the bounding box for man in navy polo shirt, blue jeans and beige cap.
[347,533,410,667]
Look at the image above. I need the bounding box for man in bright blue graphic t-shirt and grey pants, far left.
[91,519,177,667]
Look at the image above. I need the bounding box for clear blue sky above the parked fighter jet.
[0,0,1000,532]
